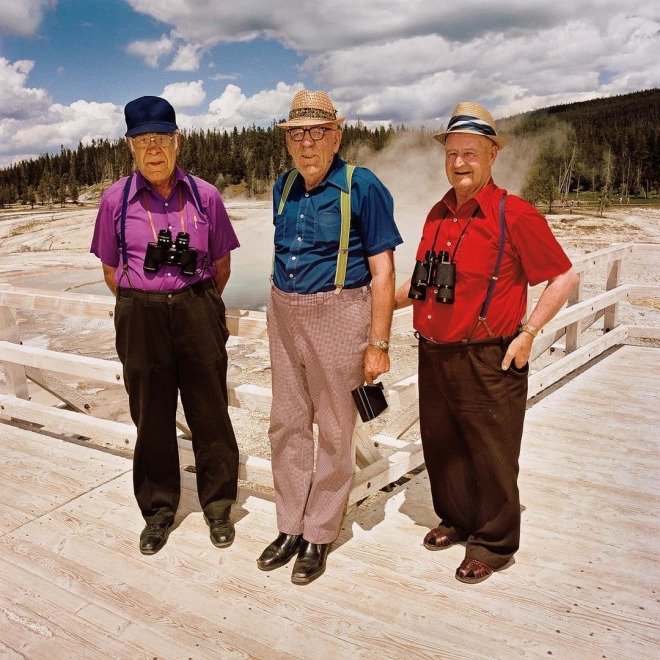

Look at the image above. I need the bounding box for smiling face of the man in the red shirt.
[445,133,497,206]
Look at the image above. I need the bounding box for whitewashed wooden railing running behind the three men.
[0,243,660,503]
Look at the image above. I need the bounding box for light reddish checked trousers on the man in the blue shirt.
[268,287,371,543]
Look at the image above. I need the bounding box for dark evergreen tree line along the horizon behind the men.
[0,89,660,210]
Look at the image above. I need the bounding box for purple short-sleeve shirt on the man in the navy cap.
[90,166,240,291]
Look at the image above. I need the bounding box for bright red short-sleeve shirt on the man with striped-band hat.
[413,179,571,342]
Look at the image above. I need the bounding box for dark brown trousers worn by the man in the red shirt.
[419,338,529,568]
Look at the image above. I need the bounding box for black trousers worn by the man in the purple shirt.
[115,280,238,523]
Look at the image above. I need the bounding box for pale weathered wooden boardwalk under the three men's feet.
[0,346,660,660]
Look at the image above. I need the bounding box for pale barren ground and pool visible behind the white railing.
[0,201,660,464]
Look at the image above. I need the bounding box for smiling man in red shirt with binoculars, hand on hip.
[396,102,577,583]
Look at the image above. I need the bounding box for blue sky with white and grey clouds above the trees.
[0,0,660,167]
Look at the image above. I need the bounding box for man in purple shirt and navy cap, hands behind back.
[91,96,239,555]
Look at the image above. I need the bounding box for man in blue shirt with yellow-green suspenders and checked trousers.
[257,90,403,584]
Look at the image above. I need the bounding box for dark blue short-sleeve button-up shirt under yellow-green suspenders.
[273,156,403,293]
